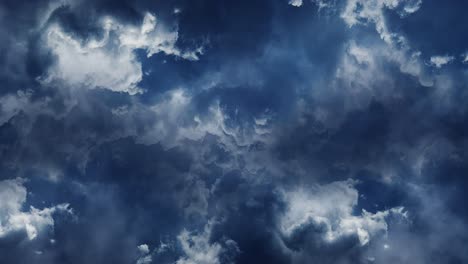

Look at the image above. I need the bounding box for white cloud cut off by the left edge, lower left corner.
[0,178,72,240]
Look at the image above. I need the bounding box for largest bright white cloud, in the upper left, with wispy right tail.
[42,13,202,94]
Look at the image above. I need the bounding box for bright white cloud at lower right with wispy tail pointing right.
[281,180,405,246]
